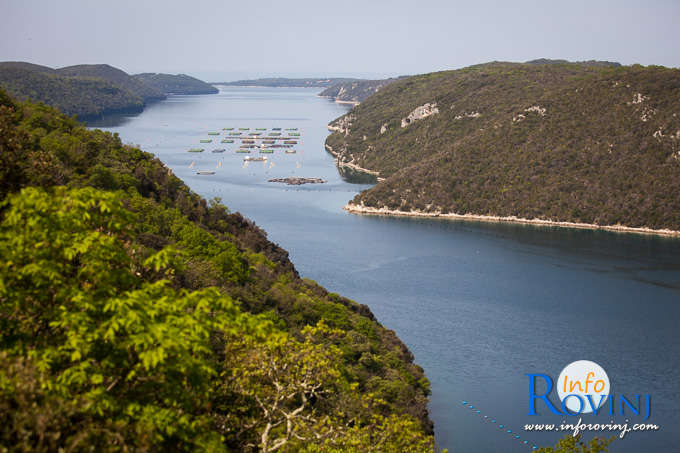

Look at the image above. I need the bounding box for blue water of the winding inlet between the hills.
[94,87,680,452]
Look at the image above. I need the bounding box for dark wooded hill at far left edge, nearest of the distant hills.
[0,62,144,119]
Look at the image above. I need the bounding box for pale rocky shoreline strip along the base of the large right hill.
[343,203,680,238]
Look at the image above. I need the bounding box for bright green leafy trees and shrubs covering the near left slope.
[0,90,433,452]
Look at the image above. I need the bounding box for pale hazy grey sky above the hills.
[0,0,680,81]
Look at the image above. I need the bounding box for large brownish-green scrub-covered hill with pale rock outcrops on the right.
[326,62,680,230]
